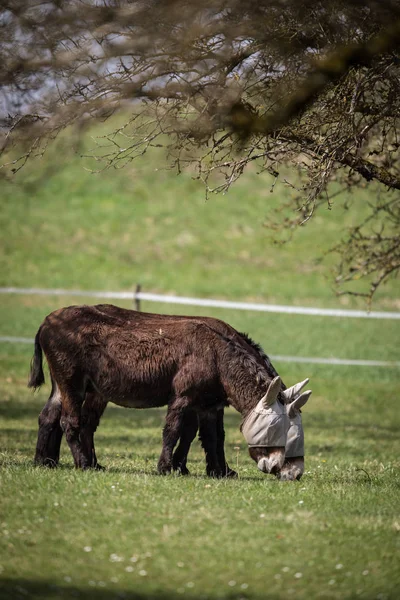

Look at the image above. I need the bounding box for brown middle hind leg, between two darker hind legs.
[60,386,91,469]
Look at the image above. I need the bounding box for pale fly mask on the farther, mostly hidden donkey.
[282,378,312,458]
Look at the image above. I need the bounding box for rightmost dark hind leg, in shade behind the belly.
[79,392,107,471]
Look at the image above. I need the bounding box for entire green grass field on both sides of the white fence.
[0,129,400,600]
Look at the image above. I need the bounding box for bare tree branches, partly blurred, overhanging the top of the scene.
[0,0,400,297]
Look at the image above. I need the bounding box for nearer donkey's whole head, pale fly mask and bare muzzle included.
[241,377,290,474]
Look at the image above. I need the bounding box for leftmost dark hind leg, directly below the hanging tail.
[34,379,63,467]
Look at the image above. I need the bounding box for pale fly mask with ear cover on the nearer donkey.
[241,377,289,448]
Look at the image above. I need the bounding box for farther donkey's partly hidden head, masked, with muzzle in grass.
[277,379,312,481]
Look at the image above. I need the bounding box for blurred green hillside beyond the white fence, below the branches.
[0,123,400,310]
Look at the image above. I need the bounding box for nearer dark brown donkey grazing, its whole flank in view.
[29,305,310,473]
